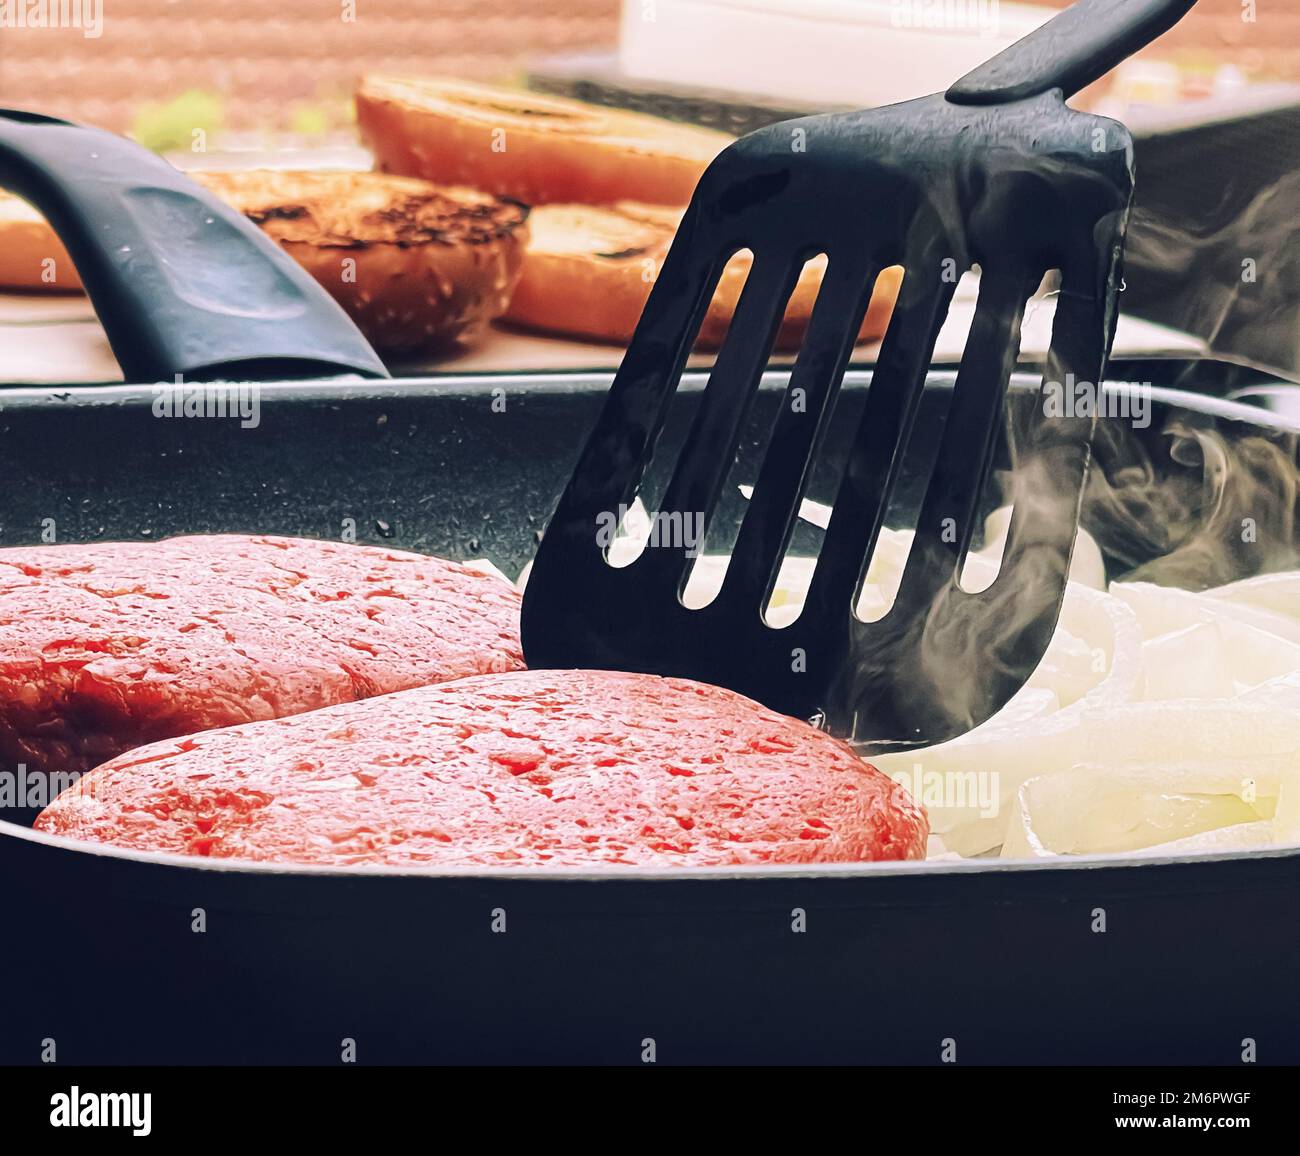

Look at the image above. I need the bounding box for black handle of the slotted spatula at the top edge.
[948,0,1196,104]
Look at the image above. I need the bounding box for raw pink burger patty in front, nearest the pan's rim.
[36,671,928,867]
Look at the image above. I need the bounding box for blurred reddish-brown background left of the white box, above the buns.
[0,0,619,135]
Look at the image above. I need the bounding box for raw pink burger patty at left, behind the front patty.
[0,534,523,772]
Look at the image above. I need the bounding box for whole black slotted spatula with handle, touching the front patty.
[523,0,1195,749]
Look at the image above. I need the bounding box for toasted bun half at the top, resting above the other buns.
[356,77,732,204]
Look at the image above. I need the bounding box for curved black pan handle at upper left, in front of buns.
[0,109,387,382]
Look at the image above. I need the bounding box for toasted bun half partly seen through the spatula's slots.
[506,202,902,350]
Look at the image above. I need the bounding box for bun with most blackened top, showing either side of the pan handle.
[0,170,528,352]
